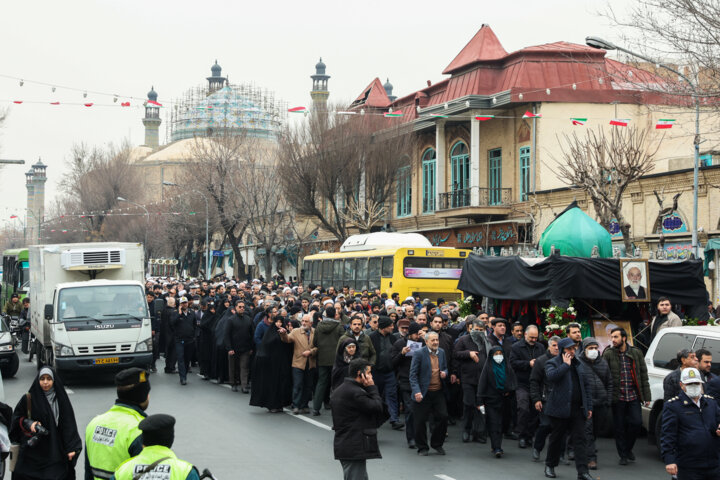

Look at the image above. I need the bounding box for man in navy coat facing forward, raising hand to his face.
[545,338,593,480]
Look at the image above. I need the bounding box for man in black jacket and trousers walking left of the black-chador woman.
[225,300,254,393]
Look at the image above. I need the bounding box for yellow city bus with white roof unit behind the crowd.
[302,232,469,302]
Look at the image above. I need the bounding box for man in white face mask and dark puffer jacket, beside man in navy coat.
[578,337,612,470]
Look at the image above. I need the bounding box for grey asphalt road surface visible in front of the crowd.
[4,358,669,480]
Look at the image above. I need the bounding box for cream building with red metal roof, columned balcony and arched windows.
[349,25,720,270]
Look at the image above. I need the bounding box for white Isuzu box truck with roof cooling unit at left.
[29,243,152,372]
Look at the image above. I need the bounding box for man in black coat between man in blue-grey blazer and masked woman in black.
[453,318,491,443]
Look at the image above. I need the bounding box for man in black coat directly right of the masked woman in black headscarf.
[510,325,545,448]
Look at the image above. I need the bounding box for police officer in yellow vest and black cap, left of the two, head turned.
[85,368,150,480]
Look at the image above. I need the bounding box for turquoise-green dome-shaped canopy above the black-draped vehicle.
[540,202,612,258]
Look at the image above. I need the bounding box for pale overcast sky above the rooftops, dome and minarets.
[0,0,630,226]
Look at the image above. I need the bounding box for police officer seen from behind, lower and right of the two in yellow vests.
[111,413,200,480]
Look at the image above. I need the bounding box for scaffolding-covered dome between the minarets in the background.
[166,83,287,142]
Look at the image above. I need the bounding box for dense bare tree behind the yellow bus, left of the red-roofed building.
[279,113,412,242]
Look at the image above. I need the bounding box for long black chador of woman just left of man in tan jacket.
[249,323,293,410]
